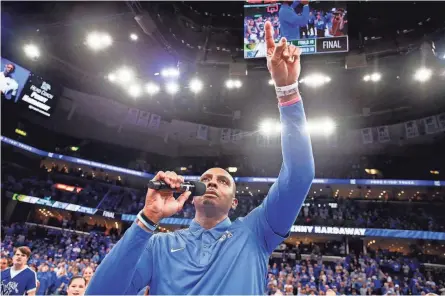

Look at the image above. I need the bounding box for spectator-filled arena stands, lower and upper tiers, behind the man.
[1,142,445,295]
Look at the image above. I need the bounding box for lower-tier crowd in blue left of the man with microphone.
[1,221,114,295]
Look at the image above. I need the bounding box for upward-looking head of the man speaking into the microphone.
[193,168,238,214]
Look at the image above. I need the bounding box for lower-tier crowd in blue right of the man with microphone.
[267,250,445,295]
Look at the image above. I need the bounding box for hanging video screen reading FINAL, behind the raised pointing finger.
[244,0,349,59]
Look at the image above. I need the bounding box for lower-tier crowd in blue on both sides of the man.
[1,223,445,295]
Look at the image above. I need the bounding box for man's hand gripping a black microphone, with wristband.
[137,171,206,231]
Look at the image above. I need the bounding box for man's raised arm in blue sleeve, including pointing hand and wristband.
[244,22,315,252]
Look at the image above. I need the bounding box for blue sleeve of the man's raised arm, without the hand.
[264,99,315,236]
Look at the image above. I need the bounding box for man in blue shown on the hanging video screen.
[278,0,309,41]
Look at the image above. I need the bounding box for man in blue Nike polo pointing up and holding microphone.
[86,22,314,295]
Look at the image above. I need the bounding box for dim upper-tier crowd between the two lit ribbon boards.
[2,161,445,231]
